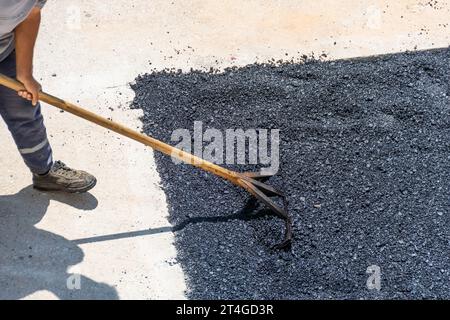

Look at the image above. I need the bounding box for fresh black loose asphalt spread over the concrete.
[133,49,450,299]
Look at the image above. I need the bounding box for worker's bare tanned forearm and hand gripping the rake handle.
[14,7,41,106]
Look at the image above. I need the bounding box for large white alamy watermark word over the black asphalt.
[171,121,280,175]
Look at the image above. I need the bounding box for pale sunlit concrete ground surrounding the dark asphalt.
[0,0,450,299]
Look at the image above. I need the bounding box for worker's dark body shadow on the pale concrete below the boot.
[0,186,118,300]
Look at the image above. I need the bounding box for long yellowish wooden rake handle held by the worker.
[0,73,242,186]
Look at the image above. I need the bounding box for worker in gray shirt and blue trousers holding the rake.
[0,0,97,193]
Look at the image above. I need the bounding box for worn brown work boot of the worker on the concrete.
[33,161,97,193]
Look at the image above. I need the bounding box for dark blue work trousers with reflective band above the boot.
[0,52,53,174]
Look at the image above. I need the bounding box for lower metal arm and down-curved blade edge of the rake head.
[241,180,292,249]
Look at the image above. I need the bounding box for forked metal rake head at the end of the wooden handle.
[239,172,292,249]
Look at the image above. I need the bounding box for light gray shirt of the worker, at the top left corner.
[0,0,47,61]
